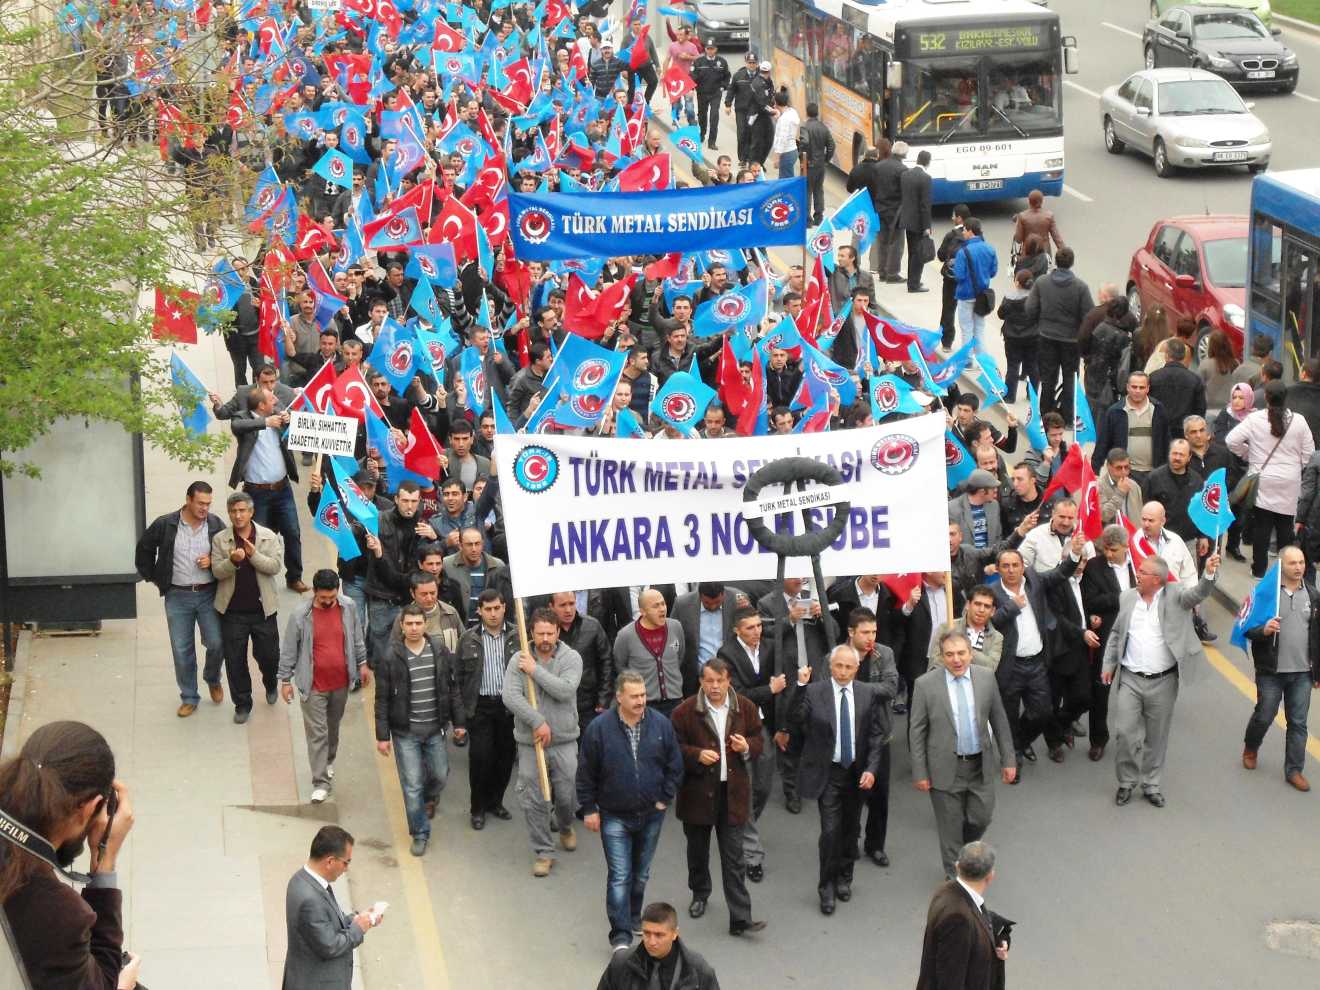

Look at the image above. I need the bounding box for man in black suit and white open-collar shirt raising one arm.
[990,529,1086,783]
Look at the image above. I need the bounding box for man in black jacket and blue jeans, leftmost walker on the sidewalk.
[133,482,224,718]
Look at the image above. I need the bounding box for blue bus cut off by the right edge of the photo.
[1246,169,1320,381]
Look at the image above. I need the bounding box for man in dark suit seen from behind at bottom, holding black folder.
[916,841,1008,990]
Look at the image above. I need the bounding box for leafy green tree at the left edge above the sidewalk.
[0,3,240,473]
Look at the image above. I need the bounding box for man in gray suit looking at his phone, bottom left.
[284,825,380,990]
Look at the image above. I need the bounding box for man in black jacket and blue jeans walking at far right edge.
[1242,546,1320,791]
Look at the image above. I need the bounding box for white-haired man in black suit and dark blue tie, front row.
[789,644,891,915]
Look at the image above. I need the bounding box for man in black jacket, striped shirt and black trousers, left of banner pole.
[458,587,517,829]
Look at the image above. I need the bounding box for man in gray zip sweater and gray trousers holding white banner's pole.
[503,609,582,878]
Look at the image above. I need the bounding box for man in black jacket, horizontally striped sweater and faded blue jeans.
[376,603,467,855]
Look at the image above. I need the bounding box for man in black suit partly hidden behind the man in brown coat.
[715,606,789,883]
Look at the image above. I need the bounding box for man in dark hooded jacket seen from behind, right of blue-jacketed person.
[1027,247,1096,422]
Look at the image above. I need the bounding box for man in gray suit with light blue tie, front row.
[908,632,1018,879]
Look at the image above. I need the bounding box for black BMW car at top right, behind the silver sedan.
[1142,5,1299,92]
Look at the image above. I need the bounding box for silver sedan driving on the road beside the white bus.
[1100,69,1271,178]
